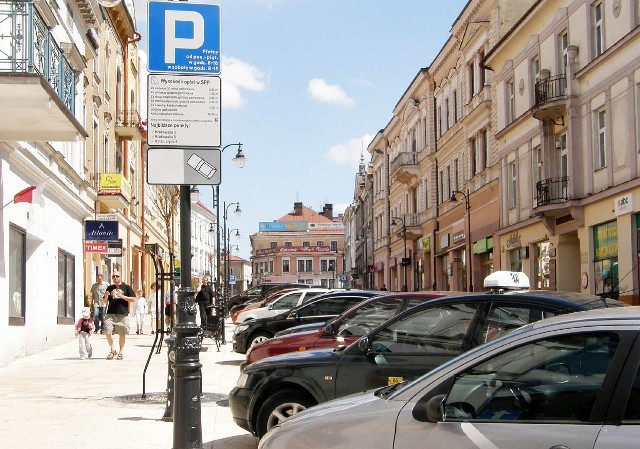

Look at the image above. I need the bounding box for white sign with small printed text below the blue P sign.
[147,73,222,148]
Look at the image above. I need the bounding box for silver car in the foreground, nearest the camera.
[259,307,640,449]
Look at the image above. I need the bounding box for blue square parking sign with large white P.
[148,1,220,74]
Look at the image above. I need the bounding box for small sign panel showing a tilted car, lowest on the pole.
[147,147,221,185]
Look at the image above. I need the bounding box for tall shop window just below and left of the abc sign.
[593,221,619,298]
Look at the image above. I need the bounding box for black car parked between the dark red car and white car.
[232,290,380,354]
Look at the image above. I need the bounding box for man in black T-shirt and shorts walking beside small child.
[104,271,136,360]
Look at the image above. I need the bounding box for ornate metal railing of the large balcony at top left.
[0,0,76,114]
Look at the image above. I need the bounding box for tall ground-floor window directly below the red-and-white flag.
[9,224,27,325]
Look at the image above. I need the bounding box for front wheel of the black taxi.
[256,390,315,438]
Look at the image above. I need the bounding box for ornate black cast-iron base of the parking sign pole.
[173,284,202,449]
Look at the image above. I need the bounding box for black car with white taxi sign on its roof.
[229,291,624,437]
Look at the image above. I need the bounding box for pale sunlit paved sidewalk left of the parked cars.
[0,317,257,449]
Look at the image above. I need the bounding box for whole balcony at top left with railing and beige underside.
[0,0,87,142]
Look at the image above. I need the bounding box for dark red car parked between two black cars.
[240,292,452,369]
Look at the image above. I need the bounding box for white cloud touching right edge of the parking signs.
[221,56,267,109]
